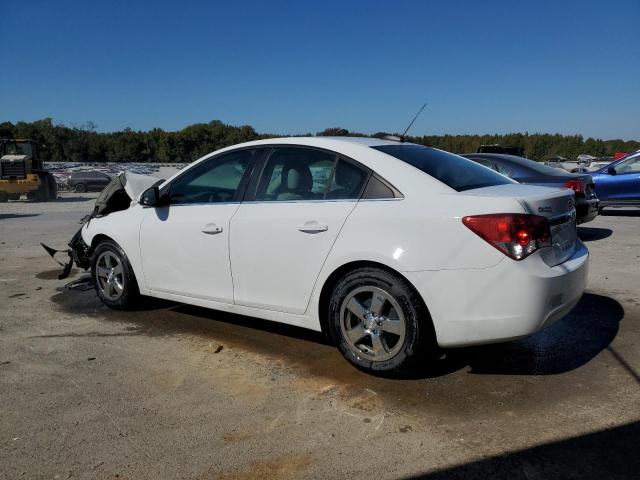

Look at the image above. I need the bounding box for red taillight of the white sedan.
[462,213,551,260]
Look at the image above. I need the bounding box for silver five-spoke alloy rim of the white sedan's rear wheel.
[340,287,406,362]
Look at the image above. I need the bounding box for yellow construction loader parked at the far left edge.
[0,139,58,202]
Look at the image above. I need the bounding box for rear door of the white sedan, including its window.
[230,146,370,314]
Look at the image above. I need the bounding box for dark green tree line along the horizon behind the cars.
[0,118,640,163]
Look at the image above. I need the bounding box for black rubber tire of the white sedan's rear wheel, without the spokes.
[328,267,437,376]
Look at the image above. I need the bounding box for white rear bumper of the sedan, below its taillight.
[405,242,589,347]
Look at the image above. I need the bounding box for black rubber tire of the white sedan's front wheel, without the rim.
[91,240,140,310]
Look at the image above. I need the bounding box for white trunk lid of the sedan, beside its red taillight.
[464,184,578,266]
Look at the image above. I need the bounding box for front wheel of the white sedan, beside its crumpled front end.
[91,240,140,310]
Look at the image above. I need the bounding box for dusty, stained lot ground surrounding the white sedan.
[0,194,640,479]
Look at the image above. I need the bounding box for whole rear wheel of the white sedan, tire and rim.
[329,268,435,374]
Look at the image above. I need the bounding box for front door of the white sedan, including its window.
[140,149,257,303]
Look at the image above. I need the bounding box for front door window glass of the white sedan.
[169,150,257,204]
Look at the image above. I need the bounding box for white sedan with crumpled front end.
[76,137,589,373]
